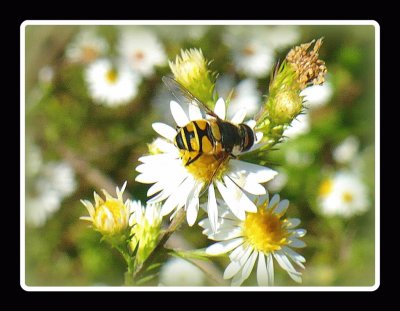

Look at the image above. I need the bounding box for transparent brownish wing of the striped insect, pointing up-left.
[162,76,219,119]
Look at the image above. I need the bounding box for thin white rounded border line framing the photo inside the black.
[20,20,380,291]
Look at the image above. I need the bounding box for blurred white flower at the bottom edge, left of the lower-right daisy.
[160,258,205,286]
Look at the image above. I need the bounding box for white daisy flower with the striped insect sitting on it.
[136,98,277,233]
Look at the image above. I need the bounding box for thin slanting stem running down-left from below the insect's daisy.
[133,209,186,280]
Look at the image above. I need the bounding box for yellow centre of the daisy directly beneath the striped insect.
[181,151,229,183]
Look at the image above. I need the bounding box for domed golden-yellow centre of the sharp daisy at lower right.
[243,206,290,253]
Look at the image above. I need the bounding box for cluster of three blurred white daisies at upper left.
[66,27,167,107]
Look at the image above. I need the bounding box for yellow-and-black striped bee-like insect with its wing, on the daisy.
[163,76,255,166]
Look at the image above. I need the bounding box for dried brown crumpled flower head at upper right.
[286,38,327,89]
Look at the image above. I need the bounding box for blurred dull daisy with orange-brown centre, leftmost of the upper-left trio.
[66,29,109,64]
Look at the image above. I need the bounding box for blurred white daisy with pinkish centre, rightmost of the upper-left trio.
[118,28,167,77]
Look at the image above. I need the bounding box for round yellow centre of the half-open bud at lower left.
[93,199,128,234]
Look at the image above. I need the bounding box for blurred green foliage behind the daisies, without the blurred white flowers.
[23,25,375,286]
